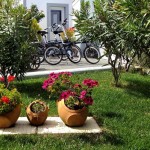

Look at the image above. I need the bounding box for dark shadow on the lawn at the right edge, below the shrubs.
[125,79,150,98]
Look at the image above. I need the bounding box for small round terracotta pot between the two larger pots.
[26,100,49,126]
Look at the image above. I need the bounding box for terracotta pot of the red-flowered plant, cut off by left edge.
[0,105,21,128]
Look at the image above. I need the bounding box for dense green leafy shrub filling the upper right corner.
[114,0,150,70]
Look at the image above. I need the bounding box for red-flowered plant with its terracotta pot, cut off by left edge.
[0,81,21,128]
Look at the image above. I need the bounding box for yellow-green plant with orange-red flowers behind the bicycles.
[61,27,76,41]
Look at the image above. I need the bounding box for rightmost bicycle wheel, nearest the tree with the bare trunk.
[83,47,100,64]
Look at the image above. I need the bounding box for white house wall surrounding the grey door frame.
[21,0,72,29]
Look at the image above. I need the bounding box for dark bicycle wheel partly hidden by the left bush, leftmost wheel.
[30,55,40,70]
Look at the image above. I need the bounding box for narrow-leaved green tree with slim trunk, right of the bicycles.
[73,0,126,86]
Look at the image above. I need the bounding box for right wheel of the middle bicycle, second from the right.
[66,46,81,63]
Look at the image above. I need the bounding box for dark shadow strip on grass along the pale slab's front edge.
[1,131,124,148]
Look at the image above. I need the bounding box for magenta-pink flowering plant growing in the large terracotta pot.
[42,72,98,110]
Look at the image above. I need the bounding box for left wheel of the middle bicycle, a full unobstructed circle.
[44,46,62,65]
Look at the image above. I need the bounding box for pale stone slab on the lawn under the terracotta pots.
[0,117,102,135]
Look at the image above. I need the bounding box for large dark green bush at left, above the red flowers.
[0,0,44,86]
